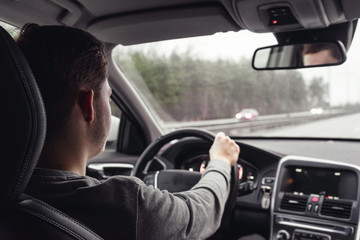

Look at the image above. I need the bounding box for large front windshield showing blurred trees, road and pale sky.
[113,31,360,138]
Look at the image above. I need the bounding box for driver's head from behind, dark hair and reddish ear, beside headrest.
[17,24,111,164]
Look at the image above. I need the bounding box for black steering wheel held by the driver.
[131,128,239,226]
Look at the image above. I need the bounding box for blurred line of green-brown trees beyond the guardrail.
[113,49,328,121]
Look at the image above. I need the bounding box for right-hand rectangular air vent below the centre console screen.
[321,199,352,218]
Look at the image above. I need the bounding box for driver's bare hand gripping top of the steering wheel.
[210,132,240,166]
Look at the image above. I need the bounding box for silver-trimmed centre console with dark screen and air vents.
[271,157,360,240]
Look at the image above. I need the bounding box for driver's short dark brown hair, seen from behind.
[17,24,107,139]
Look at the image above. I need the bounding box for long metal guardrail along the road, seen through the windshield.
[165,110,355,135]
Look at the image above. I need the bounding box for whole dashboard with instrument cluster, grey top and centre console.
[88,138,360,240]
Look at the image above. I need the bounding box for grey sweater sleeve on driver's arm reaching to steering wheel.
[136,159,231,240]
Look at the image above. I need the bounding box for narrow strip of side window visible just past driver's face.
[105,101,121,151]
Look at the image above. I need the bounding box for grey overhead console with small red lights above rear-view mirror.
[234,0,360,32]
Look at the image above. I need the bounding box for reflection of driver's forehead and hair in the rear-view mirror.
[303,43,341,66]
